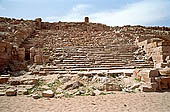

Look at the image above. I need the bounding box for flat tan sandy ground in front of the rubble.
[0,92,170,112]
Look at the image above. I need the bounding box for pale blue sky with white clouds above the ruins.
[0,0,170,26]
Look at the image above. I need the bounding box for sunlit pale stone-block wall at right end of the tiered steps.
[137,39,170,68]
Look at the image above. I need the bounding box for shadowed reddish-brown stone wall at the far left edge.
[0,41,25,73]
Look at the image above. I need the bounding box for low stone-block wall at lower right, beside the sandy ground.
[133,68,170,92]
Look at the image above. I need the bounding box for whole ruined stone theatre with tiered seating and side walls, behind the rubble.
[0,17,170,96]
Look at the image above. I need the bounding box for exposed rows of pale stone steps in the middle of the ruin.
[40,45,154,74]
